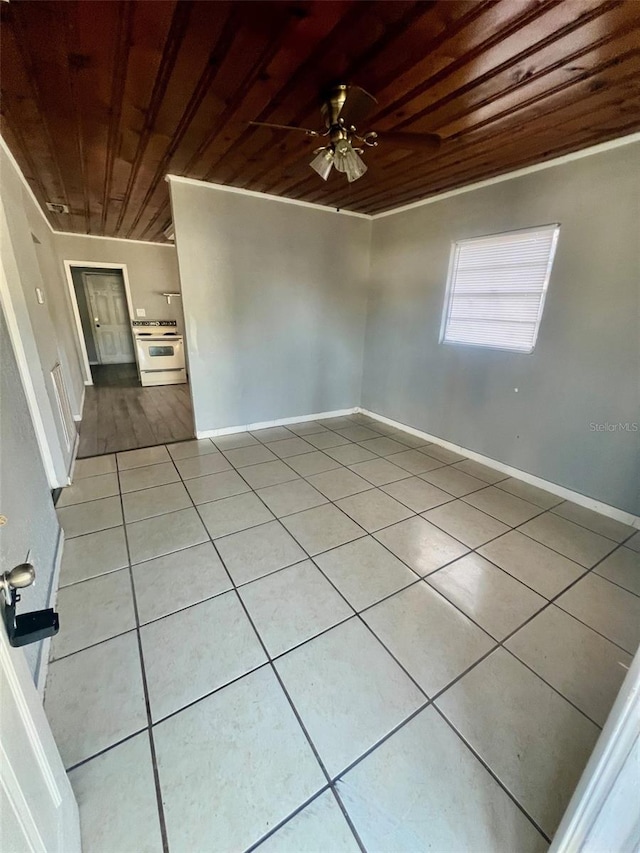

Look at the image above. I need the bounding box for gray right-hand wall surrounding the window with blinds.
[362,144,640,513]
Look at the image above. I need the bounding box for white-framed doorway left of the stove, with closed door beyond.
[69,265,140,387]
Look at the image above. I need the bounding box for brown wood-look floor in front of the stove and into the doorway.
[78,365,194,458]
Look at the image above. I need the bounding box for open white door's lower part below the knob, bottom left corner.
[0,608,81,853]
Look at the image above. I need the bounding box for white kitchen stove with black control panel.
[131,320,187,385]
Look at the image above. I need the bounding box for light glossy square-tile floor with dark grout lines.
[45,415,640,853]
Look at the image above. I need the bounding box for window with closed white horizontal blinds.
[440,225,560,352]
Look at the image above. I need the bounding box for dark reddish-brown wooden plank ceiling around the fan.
[0,0,640,240]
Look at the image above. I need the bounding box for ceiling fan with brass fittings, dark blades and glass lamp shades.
[249,84,441,183]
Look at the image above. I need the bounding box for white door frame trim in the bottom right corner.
[549,651,640,853]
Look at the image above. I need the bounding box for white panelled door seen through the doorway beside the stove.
[82,272,135,364]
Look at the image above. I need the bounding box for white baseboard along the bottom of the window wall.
[356,408,640,529]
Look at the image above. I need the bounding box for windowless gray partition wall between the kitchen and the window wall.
[171,181,371,431]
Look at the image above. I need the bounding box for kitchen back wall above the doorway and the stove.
[55,234,184,333]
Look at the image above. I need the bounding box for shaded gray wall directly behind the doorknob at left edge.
[0,307,59,680]
